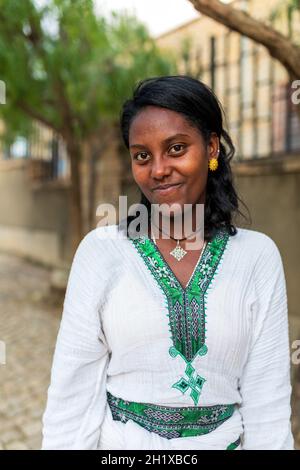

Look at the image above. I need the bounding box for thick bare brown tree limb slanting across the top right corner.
[189,0,300,81]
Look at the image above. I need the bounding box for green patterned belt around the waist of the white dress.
[107,391,240,450]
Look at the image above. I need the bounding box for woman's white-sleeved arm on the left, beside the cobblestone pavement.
[42,231,108,450]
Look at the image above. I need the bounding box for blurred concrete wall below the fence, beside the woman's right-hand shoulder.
[234,155,300,394]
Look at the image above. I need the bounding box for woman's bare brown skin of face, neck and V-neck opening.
[129,106,220,288]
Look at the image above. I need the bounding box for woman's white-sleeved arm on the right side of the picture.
[239,236,294,450]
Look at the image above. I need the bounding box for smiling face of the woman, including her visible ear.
[129,106,219,217]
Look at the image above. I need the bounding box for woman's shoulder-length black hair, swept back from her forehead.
[120,75,251,240]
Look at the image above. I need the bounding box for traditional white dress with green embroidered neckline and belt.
[42,225,294,450]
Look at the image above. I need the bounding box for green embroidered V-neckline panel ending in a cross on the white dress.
[131,228,229,405]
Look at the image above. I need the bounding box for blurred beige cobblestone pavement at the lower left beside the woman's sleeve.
[0,253,62,450]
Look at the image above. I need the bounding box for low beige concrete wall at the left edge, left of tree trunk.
[0,159,71,266]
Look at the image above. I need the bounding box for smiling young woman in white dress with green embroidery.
[42,76,294,450]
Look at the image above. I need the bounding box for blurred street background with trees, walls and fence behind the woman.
[0,0,300,450]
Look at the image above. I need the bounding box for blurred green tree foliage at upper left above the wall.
[0,0,175,145]
